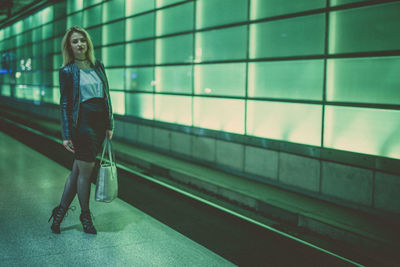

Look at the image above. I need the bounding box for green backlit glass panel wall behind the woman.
[0,0,400,159]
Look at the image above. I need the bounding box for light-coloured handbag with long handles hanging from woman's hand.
[95,137,118,202]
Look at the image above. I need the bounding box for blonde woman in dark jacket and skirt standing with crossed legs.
[49,26,114,234]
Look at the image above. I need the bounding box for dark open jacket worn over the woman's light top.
[59,60,114,140]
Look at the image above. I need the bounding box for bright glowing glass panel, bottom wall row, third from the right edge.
[193,97,245,134]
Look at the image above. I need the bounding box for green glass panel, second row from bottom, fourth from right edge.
[156,66,192,94]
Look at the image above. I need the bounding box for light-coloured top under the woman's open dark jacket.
[79,69,104,103]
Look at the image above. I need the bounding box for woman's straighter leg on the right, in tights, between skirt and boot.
[75,160,94,212]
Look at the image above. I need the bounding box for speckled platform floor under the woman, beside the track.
[0,132,233,266]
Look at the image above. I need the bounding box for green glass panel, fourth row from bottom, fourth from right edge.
[156,2,193,36]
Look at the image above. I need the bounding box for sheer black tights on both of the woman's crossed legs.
[61,160,94,212]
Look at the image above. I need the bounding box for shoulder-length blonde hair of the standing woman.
[61,26,96,67]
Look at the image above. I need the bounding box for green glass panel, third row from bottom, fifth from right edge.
[126,40,154,65]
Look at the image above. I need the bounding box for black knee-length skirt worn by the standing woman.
[72,98,106,162]
